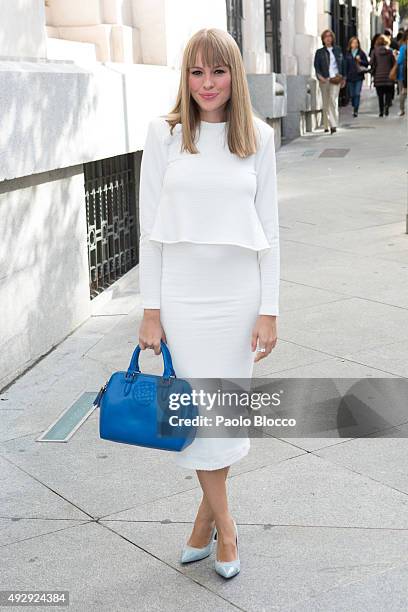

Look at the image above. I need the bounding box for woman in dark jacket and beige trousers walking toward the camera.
[314,30,346,134]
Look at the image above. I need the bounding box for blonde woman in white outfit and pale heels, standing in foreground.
[139,28,279,578]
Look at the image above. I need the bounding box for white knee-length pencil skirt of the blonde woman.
[160,242,261,470]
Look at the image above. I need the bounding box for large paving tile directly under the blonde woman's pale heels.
[103,521,408,612]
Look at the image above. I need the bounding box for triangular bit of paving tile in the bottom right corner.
[285,555,408,612]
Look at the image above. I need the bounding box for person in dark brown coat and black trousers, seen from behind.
[370,34,396,117]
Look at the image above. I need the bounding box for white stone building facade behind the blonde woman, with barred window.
[0,0,286,388]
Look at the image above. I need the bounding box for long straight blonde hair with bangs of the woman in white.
[164,28,258,157]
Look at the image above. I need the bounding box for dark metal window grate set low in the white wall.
[84,153,139,299]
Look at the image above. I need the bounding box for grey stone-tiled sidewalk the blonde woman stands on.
[0,91,408,612]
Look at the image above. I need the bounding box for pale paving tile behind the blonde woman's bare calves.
[104,453,408,529]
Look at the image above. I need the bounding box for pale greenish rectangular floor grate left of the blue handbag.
[36,391,97,442]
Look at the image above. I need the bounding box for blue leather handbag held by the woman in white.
[93,340,198,451]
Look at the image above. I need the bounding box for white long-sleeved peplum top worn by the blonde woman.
[139,116,280,315]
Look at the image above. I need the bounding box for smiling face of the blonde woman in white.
[188,56,231,121]
